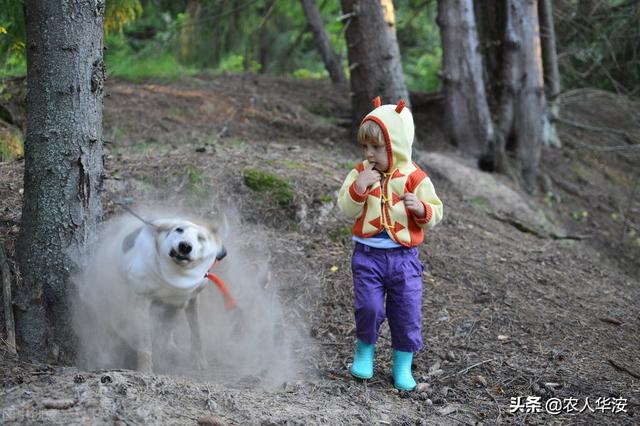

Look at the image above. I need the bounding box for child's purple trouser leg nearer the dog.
[351,250,386,344]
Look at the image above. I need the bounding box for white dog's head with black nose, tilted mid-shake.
[153,219,226,269]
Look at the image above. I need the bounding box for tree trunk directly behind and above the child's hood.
[341,0,409,124]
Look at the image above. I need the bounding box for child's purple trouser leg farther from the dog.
[386,248,424,352]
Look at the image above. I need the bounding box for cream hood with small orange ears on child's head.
[362,96,415,172]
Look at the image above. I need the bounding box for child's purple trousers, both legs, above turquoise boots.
[351,243,423,352]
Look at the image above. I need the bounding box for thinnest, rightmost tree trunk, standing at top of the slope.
[538,0,561,147]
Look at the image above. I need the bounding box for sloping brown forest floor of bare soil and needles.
[0,75,640,425]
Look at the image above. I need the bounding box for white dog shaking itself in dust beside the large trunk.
[77,218,227,372]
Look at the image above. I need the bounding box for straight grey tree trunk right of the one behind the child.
[438,0,494,158]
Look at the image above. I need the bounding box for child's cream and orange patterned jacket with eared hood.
[338,101,442,247]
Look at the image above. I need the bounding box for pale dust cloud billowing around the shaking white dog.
[73,207,304,387]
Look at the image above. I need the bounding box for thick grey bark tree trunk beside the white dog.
[16,0,105,362]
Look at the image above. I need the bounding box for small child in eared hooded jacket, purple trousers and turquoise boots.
[338,97,442,390]
